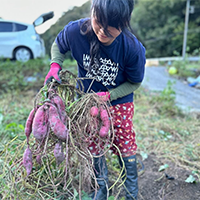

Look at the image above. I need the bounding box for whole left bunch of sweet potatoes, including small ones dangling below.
[23,92,69,175]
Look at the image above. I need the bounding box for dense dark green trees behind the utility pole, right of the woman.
[131,0,200,58]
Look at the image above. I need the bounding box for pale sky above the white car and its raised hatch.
[0,0,88,34]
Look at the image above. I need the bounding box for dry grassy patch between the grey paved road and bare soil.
[134,88,200,181]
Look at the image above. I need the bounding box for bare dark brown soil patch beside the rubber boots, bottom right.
[138,155,200,200]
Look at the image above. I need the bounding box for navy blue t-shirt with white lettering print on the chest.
[56,18,146,105]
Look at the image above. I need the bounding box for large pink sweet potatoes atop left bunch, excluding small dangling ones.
[25,94,68,141]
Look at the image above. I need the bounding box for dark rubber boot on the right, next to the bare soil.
[119,155,138,200]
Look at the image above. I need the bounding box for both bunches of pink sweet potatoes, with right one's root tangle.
[23,90,112,175]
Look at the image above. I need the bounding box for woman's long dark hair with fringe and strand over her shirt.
[81,0,134,70]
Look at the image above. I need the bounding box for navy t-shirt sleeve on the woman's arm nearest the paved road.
[125,39,146,83]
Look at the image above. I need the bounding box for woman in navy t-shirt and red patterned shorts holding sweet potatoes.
[45,0,145,200]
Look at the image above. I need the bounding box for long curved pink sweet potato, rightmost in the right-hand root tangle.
[99,107,110,137]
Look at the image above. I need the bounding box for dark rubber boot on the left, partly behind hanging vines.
[91,156,108,200]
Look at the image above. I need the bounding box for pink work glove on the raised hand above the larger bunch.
[44,63,62,85]
